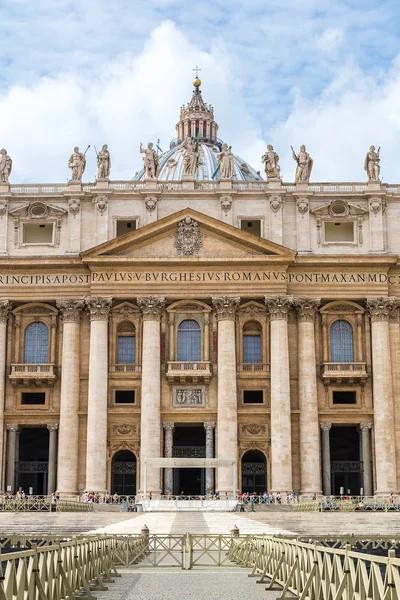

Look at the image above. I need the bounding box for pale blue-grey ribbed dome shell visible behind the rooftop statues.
[134,143,262,181]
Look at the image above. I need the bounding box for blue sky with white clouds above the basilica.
[0,0,400,183]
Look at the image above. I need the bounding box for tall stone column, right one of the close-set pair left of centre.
[86,298,112,492]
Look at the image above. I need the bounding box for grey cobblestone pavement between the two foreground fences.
[98,567,280,600]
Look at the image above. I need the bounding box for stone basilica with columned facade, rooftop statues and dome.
[0,79,400,495]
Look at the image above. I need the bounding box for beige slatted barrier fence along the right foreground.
[228,536,400,600]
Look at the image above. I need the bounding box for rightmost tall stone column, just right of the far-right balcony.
[367,298,397,495]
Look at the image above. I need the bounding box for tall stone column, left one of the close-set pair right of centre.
[265,296,293,494]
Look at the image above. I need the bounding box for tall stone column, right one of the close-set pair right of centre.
[295,298,321,494]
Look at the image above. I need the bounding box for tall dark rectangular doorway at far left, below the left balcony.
[15,427,49,496]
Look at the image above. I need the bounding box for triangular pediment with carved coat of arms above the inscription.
[82,209,296,262]
